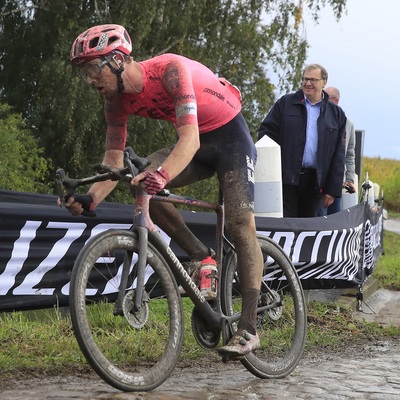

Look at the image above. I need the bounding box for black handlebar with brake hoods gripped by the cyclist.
[56,147,151,217]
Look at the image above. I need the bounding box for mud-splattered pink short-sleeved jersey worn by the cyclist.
[105,54,242,149]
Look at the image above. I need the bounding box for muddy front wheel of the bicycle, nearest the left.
[70,230,183,391]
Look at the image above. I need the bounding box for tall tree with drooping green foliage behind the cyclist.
[0,0,346,199]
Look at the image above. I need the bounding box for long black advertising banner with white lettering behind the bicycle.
[0,190,383,311]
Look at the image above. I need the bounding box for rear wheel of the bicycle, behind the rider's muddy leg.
[221,235,307,378]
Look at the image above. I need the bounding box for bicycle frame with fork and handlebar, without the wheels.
[57,148,279,336]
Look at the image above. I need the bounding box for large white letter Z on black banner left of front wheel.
[13,222,87,295]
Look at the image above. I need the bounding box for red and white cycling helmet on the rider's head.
[70,24,132,65]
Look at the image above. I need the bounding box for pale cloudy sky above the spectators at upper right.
[304,0,400,160]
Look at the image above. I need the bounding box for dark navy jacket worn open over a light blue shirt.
[258,90,346,197]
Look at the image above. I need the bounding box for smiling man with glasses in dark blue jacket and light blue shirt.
[258,64,346,217]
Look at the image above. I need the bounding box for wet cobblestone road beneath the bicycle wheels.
[0,338,400,400]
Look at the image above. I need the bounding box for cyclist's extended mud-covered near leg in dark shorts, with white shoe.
[196,114,263,359]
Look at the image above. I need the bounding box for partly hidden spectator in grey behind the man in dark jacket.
[318,86,356,216]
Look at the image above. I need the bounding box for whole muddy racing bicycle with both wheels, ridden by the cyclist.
[57,148,307,391]
